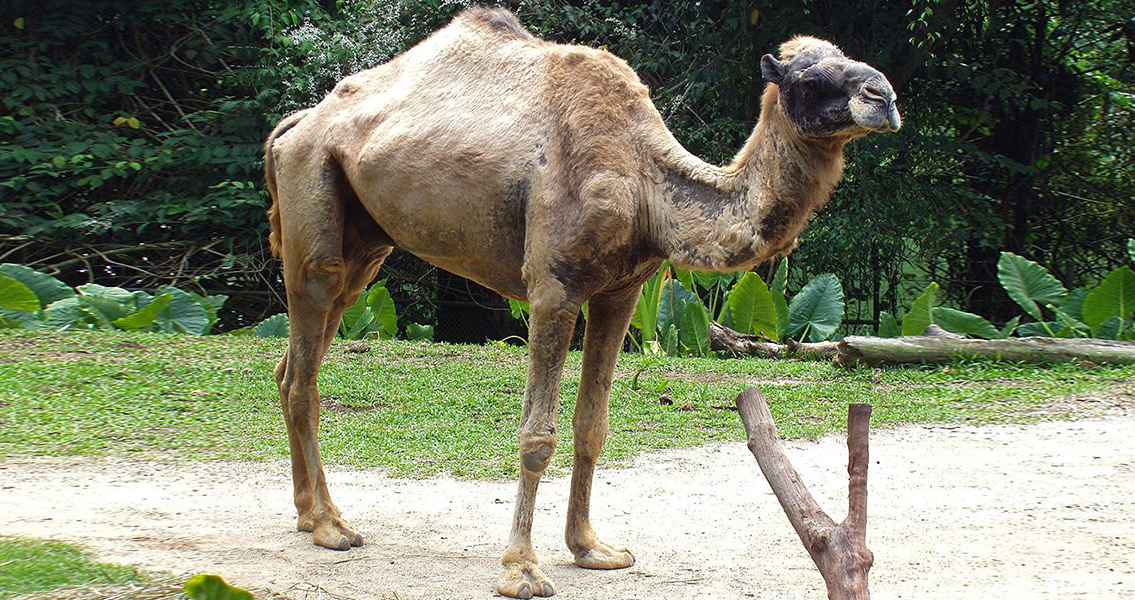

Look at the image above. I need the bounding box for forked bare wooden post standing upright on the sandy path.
[737,388,874,600]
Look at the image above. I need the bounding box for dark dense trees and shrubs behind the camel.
[0,0,1135,341]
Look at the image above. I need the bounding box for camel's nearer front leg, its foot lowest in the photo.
[497,282,581,598]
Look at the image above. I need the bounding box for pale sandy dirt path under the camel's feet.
[0,414,1135,600]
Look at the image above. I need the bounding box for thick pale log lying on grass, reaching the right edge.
[835,336,1135,367]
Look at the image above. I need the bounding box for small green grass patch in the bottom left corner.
[0,538,146,599]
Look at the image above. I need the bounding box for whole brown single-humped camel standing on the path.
[264,8,900,598]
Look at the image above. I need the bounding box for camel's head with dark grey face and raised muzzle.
[760,36,902,138]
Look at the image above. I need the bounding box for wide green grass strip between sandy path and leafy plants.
[0,331,1135,478]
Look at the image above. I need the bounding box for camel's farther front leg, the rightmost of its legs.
[564,287,639,569]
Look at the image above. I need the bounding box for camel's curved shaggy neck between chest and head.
[649,90,846,271]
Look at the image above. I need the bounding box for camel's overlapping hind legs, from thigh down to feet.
[276,148,390,550]
